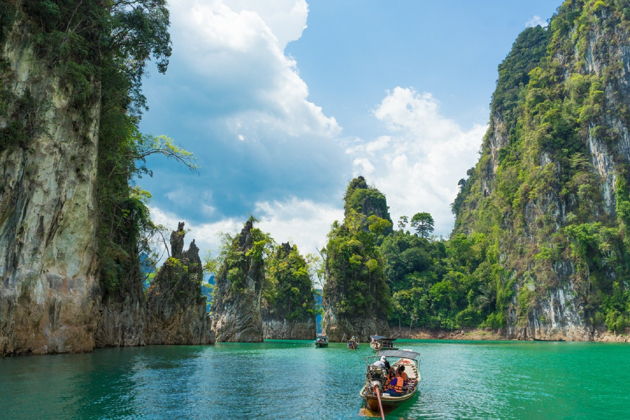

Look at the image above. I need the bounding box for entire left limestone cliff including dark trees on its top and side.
[0,0,212,356]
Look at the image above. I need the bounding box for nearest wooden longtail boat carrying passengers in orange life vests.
[359,350,421,418]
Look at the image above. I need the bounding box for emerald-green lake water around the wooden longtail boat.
[0,340,630,419]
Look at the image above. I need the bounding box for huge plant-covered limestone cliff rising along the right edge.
[453,0,630,340]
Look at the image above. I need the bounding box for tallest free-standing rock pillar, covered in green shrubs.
[323,177,392,341]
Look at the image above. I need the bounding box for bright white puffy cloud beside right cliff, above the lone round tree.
[347,87,487,236]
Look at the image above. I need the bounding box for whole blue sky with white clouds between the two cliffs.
[138,0,559,258]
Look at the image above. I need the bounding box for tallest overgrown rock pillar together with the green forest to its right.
[323,177,500,329]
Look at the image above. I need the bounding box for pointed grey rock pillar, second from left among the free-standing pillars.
[212,219,265,342]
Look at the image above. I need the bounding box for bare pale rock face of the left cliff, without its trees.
[0,20,99,354]
